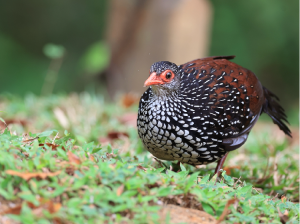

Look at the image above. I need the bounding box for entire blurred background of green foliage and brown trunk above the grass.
[0,0,300,125]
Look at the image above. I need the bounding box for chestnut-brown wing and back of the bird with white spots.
[180,56,265,150]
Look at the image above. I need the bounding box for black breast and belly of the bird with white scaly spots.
[137,88,225,165]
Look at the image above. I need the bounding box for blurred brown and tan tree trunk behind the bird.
[107,0,212,97]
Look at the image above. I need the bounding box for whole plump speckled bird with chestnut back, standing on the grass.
[137,56,292,175]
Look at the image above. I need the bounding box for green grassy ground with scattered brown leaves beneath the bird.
[0,93,300,223]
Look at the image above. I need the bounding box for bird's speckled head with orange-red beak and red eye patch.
[144,61,180,95]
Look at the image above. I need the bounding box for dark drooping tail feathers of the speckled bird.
[263,87,292,137]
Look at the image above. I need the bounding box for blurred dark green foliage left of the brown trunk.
[0,0,108,95]
